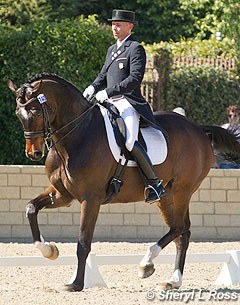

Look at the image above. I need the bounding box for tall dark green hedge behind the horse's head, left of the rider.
[0,16,113,164]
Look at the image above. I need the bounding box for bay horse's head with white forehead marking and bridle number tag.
[8,80,53,161]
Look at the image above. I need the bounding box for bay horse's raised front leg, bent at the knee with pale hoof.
[26,185,72,259]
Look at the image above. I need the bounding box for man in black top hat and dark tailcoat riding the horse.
[83,9,166,203]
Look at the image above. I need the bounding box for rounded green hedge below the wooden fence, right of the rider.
[162,67,240,125]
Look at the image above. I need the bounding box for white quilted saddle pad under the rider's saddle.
[99,105,167,166]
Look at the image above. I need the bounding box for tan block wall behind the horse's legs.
[0,165,240,241]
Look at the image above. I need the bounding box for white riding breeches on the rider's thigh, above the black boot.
[108,98,140,151]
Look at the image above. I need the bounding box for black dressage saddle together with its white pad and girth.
[99,101,167,202]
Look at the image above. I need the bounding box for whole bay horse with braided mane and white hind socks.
[8,73,240,291]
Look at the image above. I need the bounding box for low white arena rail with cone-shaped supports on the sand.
[0,250,240,288]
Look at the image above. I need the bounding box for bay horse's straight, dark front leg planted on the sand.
[65,201,100,291]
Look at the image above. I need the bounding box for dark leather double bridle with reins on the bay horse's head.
[16,94,95,150]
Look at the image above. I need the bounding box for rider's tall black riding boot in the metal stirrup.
[131,141,166,203]
